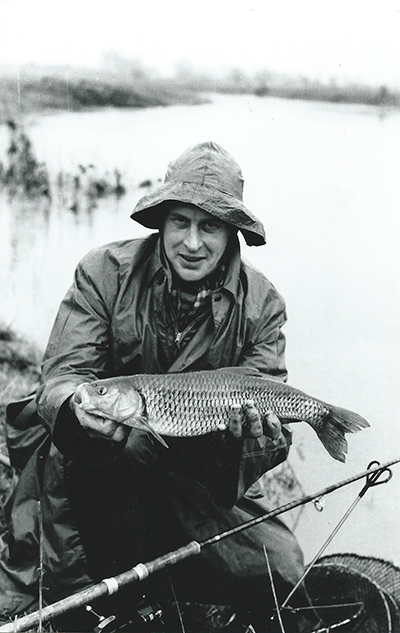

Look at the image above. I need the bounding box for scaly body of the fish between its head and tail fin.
[128,371,328,436]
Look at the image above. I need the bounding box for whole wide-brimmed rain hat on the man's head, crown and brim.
[131,141,265,246]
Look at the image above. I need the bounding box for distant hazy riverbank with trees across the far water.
[0,67,400,123]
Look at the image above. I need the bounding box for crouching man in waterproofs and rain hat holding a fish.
[3,142,316,631]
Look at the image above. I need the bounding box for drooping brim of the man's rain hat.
[131,182,265,246]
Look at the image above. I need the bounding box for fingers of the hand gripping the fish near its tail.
[227,400,282,440]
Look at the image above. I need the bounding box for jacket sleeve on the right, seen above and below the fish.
[207,287,292,508]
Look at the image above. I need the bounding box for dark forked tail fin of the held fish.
[314,406,369,462]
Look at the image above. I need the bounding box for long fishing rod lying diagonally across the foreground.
[0,457,400,633]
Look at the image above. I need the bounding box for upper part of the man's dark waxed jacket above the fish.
[38,235,286,430]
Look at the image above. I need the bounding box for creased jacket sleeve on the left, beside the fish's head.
[36,253,117,450]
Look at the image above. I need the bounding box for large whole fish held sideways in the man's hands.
[76,367,369,462]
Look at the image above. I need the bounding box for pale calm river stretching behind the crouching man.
[0,96,400,565]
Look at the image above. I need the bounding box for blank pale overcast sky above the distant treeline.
[0,0,400,87]
